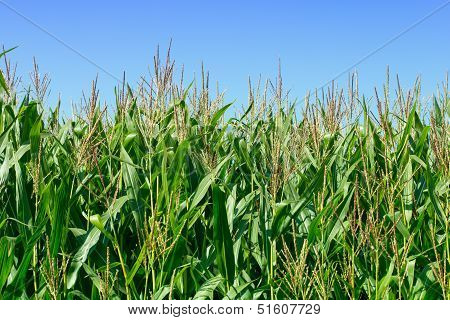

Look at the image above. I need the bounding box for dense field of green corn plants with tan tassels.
[0,47,450,299]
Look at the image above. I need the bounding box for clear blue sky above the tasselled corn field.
[0,0,450,110]
